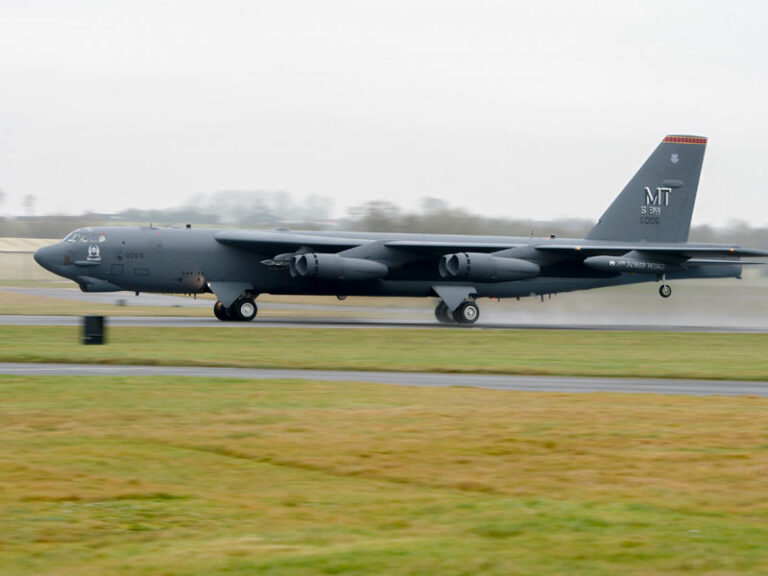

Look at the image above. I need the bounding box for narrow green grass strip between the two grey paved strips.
[0,325,768,380]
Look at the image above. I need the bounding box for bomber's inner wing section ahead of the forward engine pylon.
[213,230,370,253]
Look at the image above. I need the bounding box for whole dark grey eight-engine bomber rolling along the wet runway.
[35,136,768,324]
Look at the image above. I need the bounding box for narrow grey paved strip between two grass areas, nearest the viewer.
[0,363,768,397]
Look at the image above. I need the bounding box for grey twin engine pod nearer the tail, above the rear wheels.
[440,252,541,282]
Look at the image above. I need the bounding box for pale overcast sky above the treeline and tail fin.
[0,0,768,225]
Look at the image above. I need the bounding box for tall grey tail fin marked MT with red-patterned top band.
[587,136,707,242]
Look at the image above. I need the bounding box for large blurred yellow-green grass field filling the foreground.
[0,376,768,576]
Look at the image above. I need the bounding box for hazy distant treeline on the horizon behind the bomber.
[0,193,768,249]
